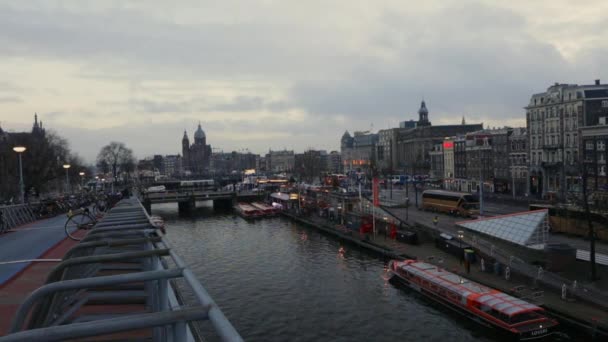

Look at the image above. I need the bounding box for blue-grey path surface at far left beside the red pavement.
[0,214,67,286]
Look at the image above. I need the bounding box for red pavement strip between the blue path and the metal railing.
[0,230,85,336]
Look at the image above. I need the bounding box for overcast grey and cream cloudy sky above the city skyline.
[0,0,608,161]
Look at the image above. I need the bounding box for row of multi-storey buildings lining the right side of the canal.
[340,80,608,198]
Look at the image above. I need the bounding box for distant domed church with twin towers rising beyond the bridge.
[182,123,211,175]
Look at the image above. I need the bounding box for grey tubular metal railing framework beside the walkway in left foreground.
[0,198,242,341]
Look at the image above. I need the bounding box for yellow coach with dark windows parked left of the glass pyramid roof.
[421,190,479,217]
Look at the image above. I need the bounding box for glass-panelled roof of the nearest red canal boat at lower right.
[400,261,542,316]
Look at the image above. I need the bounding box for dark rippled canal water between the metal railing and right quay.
[153,202,560,341]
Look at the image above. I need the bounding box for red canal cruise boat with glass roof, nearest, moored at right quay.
[389,260,558,341]
